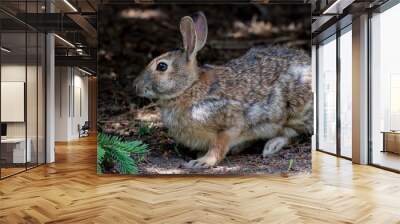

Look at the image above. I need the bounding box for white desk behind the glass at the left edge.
[1,138,32,163]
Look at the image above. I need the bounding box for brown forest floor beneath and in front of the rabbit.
[98,108,311,175]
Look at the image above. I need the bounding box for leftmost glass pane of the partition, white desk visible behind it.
[1,32,27,177]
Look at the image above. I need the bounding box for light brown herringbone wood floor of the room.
[0,138,400,224]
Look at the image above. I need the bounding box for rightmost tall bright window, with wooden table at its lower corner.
[370,1,400,170]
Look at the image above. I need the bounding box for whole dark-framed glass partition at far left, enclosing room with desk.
[0,1,46,178]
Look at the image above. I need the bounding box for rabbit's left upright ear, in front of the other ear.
[180,16,197,60]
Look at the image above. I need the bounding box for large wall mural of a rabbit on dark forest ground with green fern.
[97,4,313,175]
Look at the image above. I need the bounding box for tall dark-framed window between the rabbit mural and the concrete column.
[317,24,353,158]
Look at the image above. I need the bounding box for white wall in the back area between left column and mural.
[55,67,89,141]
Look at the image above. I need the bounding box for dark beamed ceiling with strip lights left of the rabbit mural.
[0,0,97,71]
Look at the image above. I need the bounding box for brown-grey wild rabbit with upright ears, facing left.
[134,12,313,169]
